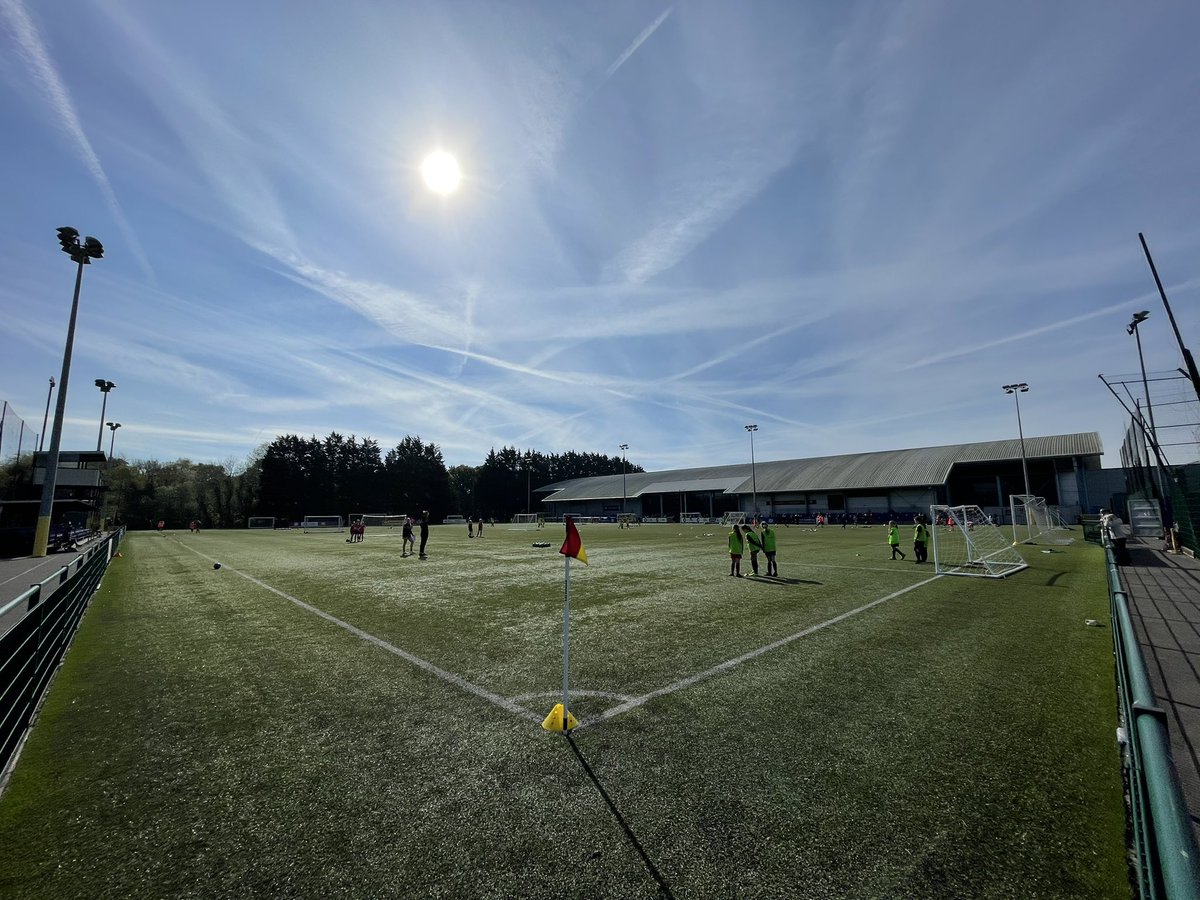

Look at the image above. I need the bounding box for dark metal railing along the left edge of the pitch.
[0,529,125,786]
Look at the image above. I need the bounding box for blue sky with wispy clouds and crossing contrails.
[0,0,1200,480]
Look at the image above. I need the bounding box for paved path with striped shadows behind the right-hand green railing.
[1120,539,1200,842]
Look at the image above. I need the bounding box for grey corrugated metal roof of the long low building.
[538,431,1104,503]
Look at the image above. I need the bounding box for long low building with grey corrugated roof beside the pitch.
[538,432,1124,521]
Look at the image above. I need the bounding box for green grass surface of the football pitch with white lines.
[0,526,1129,898]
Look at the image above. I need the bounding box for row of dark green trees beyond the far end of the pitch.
[0,432,643,528]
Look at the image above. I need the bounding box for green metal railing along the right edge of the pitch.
[1104,544,1200,900]
